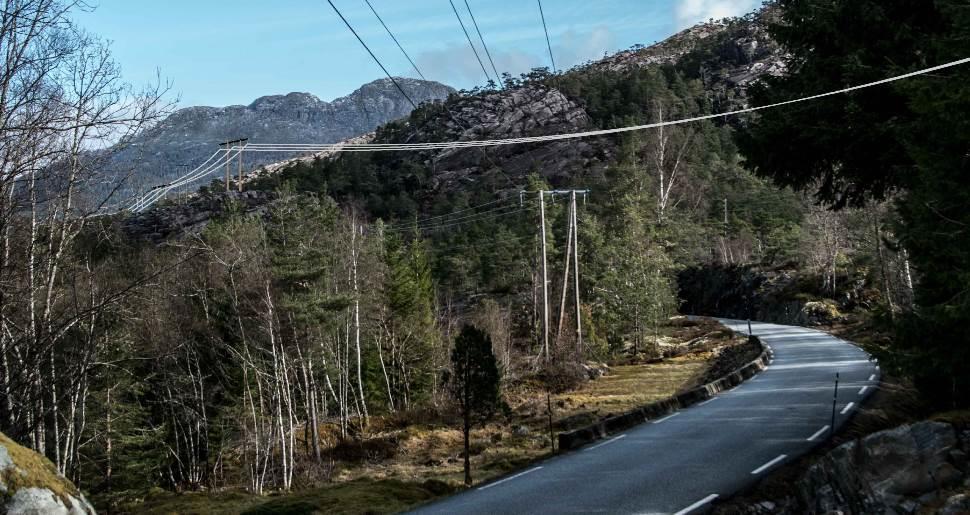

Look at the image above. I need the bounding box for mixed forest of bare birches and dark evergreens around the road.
[0,0,970,511]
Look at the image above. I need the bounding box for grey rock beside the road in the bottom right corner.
[798,422,966,515]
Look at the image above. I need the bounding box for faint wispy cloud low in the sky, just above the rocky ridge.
[415,26,616,88]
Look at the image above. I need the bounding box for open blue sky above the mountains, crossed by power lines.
[74,0,761,107]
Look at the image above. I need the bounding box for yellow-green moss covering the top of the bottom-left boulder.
[0,433,81,506]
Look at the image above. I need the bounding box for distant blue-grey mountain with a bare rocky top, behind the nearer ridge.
[112,78,455,196]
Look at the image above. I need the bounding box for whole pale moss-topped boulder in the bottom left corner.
[0,434,95,515]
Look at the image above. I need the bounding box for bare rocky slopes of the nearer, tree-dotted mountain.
[130,9,785,240]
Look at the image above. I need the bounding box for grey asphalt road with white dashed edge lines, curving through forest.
[415,320,879,514]
